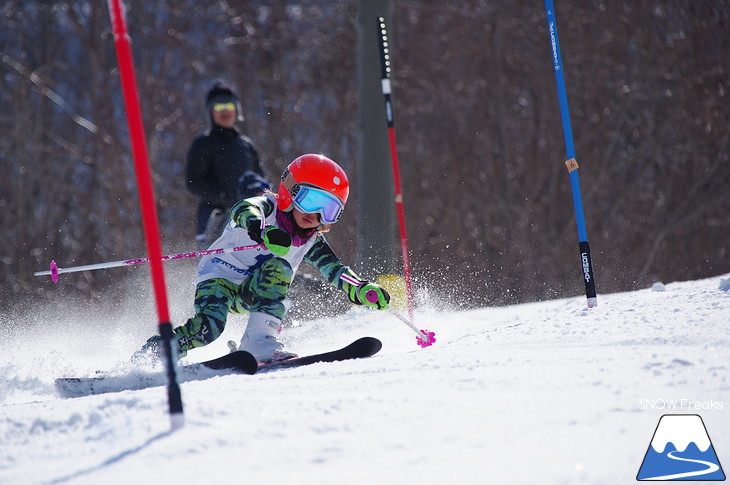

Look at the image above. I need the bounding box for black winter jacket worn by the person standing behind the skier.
[186,125,264,207]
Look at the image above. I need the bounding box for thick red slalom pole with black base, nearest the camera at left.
[109,0,185,429]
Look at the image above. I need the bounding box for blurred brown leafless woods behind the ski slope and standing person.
[0,0,730,312]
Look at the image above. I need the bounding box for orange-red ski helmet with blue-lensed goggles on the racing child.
[278,154,350,226]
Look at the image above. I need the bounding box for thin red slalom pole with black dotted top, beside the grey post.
[377,17,413,320]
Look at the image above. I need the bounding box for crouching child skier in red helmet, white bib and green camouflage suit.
[135,154,390,363]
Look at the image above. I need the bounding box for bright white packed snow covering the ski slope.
[0,275,730,485]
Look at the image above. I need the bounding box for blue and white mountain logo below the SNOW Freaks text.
[636,414,725,481]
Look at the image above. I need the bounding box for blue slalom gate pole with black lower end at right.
[545,0,598,308]
